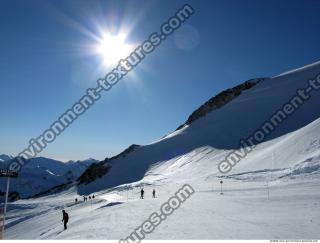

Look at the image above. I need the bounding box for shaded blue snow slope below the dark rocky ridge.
[78,62,320,196]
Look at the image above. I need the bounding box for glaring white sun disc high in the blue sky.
[97,33,133,67]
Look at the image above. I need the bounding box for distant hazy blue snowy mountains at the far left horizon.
[0,156,98,198]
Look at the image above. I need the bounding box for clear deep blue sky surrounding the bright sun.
[0,0,320,161]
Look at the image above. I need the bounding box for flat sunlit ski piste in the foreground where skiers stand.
[6,176,320,240]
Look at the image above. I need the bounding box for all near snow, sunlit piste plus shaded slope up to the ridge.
[1,60,320,240]
